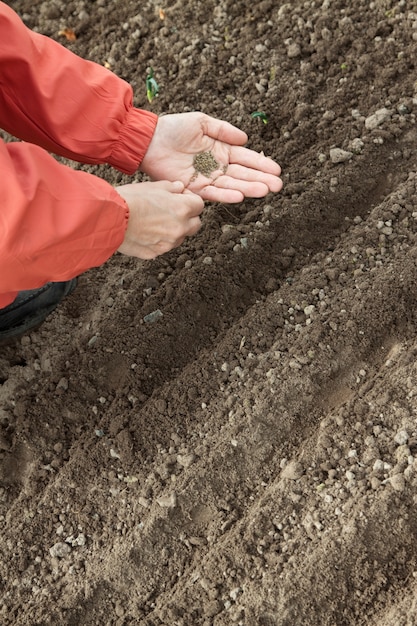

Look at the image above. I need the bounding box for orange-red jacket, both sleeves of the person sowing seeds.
[0,2,157,308]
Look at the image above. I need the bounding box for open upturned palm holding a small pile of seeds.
[140,112,282,202]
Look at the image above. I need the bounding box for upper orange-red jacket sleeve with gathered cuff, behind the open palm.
[0,2,157,174]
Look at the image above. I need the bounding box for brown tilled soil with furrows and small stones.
[0,0,417,626]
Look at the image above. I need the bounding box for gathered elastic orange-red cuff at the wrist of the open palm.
[108,108,158,174]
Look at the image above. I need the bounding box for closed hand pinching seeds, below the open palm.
[116,181,204,259]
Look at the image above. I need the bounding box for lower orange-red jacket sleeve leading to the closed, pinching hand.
[0,141,128,306]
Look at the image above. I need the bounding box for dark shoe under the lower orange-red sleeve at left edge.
[0,278,77,342]
